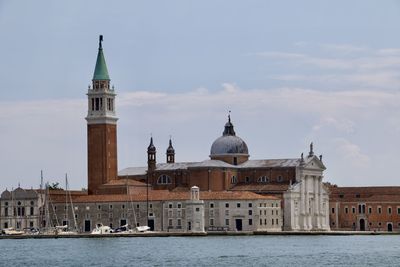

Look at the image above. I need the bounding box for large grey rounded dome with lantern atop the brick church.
[210,116,249,156]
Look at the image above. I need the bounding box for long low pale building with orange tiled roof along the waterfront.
[47,186,283,233]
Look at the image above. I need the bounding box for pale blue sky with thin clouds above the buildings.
[0,0,400,191]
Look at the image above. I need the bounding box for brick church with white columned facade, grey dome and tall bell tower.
[86,36,329,233]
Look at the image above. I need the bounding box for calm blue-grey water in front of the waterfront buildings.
[0,235,400,266]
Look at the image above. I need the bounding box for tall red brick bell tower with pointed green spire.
[86,35,118,194]
